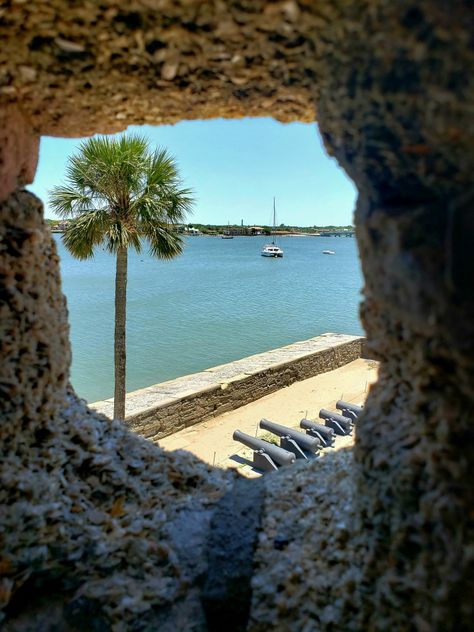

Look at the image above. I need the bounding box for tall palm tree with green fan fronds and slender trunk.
[50,135,193,420]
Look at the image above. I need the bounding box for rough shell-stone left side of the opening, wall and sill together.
[0,191,233,632]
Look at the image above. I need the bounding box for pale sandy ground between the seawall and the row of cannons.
[159,358,378,476]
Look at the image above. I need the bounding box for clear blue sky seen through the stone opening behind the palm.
[28,118,356,226]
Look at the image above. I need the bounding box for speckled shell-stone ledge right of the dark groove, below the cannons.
[247,450,360,632]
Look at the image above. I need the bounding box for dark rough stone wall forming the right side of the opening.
[319,1,474,630]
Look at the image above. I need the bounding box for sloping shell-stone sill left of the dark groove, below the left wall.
[0,396,232,632]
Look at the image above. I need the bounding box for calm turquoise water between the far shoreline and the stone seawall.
[54,235,362,402]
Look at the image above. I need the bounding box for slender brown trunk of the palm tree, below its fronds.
[114,248,128,421]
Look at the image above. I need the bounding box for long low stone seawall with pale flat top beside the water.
[91,334,364,441]
